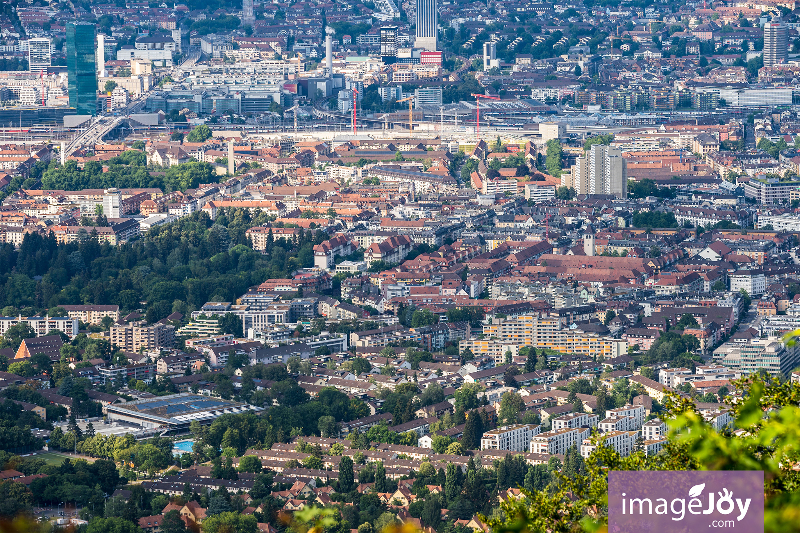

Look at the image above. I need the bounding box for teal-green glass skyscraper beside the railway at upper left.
[67,22,97,115]
